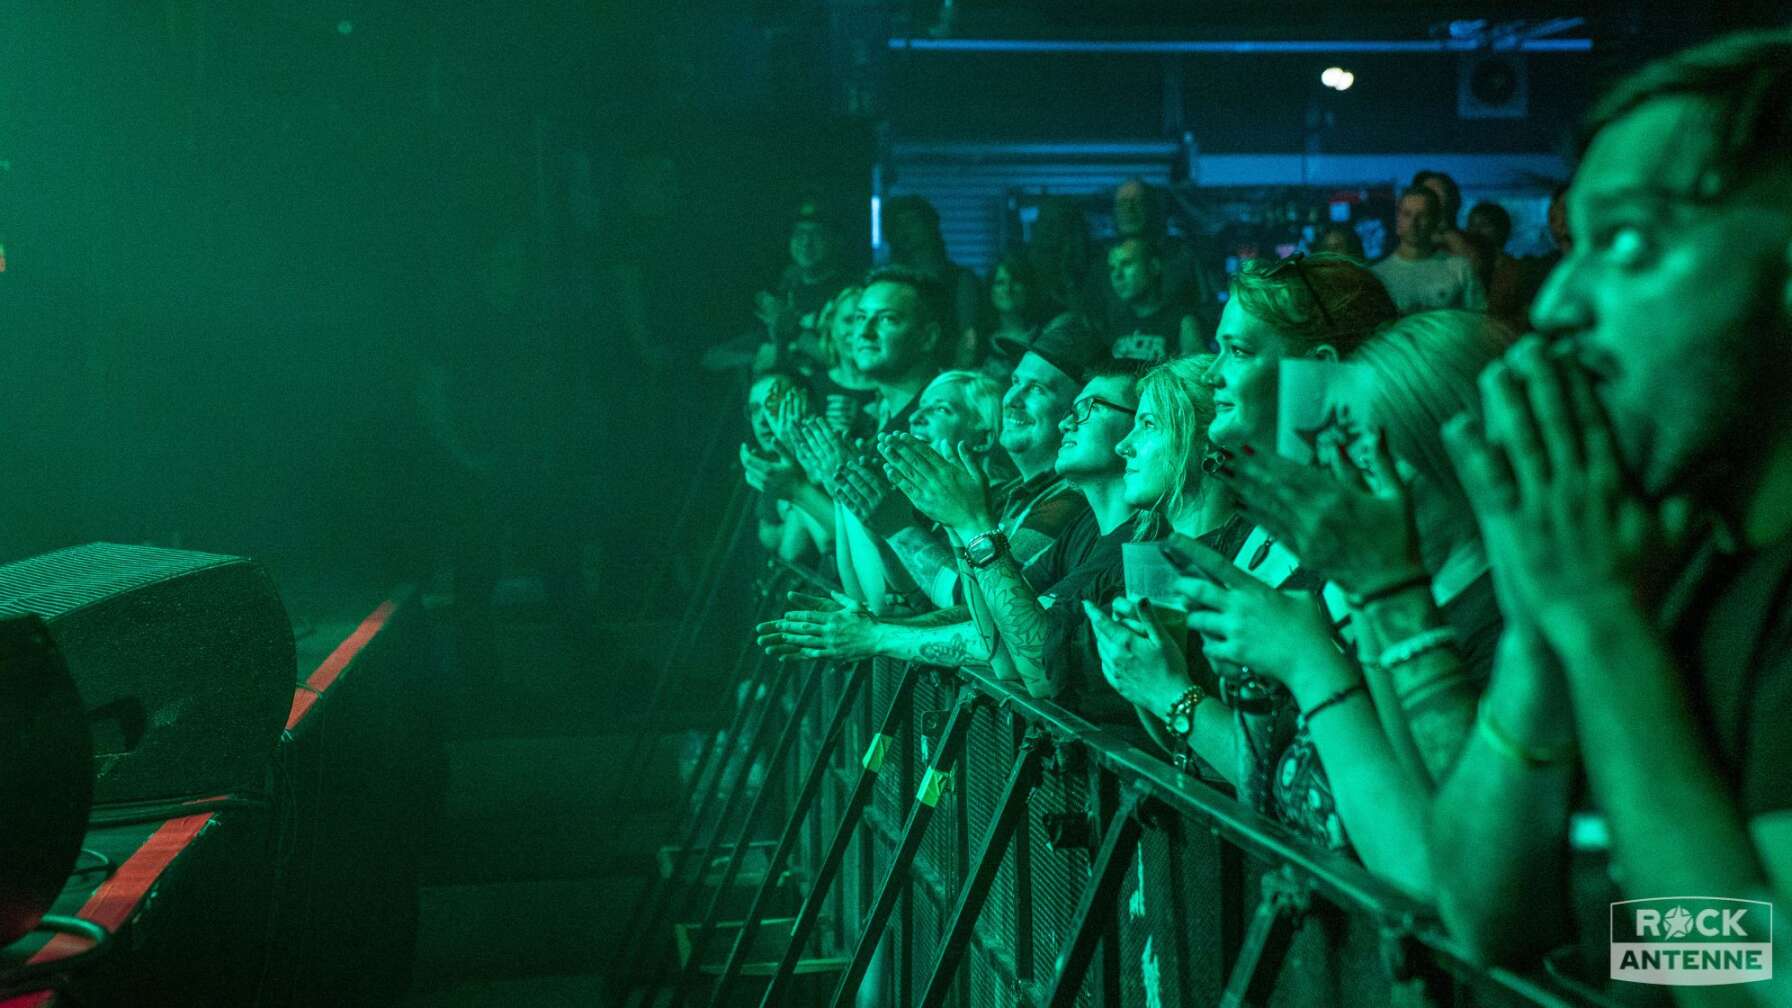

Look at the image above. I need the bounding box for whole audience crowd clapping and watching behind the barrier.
[711,32,1792,1004]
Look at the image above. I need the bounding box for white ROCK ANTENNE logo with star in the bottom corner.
[1611,897,1774,986]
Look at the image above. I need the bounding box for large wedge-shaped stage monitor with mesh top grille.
[0,543,297,805]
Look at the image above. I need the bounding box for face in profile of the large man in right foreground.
[1532,97,1792,495]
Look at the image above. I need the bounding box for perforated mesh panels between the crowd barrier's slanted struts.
[713,627,1598,1008]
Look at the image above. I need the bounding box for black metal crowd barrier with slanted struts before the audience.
[640,620,1612,1008]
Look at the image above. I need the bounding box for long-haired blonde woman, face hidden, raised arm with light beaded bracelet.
[1219,310,1514,786]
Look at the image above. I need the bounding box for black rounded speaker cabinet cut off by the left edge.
[0,617,93,947]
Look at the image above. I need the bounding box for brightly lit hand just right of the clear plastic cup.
[1174,543,1337,694]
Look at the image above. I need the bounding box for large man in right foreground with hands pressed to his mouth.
[1430,30,1792,1004]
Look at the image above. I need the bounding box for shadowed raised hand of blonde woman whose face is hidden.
[1215,434,1423,592]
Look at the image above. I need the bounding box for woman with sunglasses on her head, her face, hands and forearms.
[1090,255,1469,891]
